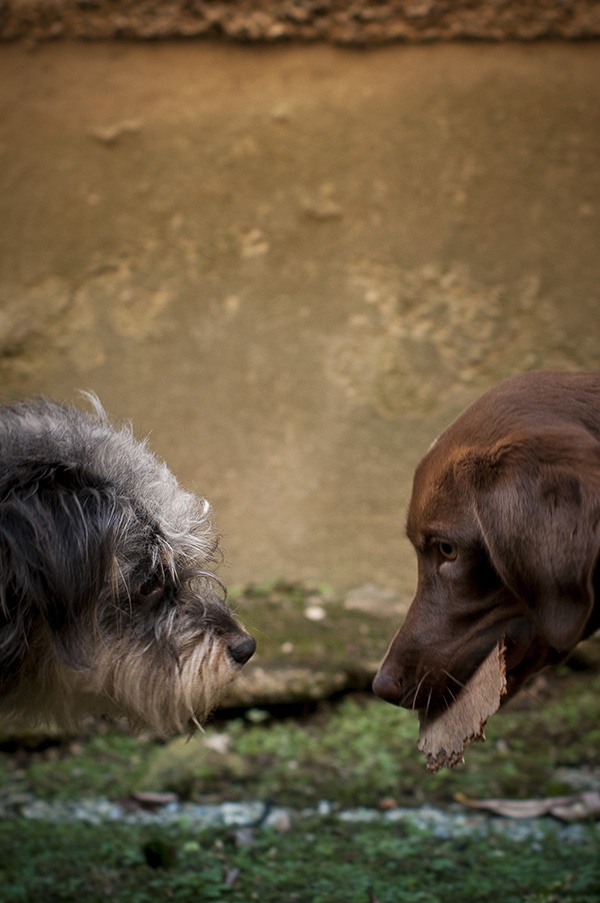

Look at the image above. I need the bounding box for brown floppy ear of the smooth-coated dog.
[460,428,600,652]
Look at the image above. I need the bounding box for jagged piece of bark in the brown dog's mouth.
[419,643,506,771]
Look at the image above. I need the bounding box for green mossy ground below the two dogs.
[0,584,600,903]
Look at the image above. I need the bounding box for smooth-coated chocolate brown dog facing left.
[373,372,600,712]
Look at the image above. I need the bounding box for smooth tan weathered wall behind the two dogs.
[0,42,600,593]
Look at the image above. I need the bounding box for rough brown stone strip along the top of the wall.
[0,0,600,45]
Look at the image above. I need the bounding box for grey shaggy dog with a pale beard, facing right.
[0,396,255,735]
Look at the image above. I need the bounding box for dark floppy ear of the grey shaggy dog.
[0,462,115,666]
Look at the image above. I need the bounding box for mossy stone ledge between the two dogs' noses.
[221,581,410,709]
